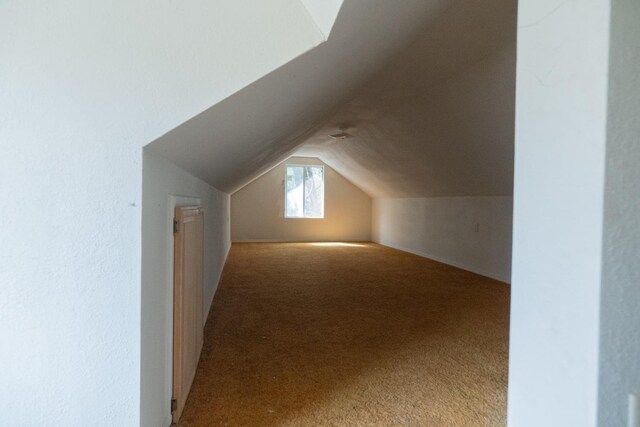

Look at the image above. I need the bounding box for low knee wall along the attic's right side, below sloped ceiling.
[372,197,513,282]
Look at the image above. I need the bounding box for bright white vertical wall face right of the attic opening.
[508,0,609,427]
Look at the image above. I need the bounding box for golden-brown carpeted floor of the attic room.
[179,243,509,427]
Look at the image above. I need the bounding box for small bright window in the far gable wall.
[284,165,324,218]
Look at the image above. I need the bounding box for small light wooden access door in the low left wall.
[172,206,204,422]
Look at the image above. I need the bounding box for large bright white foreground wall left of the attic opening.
[0,0,323,427]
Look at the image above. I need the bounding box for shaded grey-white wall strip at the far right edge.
[598,0,640,427]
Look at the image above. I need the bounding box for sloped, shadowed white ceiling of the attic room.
[149,0,516,197]
